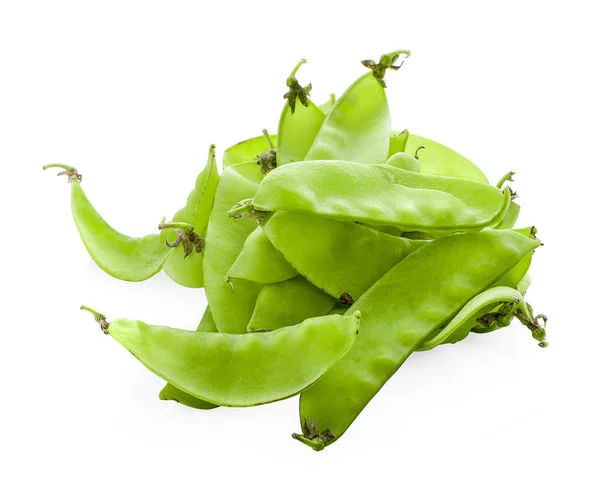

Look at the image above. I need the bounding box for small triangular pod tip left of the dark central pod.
[225,226,298,286]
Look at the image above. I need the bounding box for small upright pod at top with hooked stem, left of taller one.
[277,59,325,166]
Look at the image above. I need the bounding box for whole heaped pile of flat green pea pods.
[44,50,547,451]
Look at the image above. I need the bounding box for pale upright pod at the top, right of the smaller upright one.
[305,72,391,164]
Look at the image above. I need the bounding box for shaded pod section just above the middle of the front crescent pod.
[248,276,337,331]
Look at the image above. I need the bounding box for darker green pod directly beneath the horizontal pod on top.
[263,211,427,303]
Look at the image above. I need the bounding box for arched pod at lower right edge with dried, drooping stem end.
[417,286,545,351]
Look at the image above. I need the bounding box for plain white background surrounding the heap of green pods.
[0,0,600,496]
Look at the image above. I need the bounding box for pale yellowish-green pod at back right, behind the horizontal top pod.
[404,134,488,184]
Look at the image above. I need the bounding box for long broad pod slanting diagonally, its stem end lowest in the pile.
[294,229,539,450]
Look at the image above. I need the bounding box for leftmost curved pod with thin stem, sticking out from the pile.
[44,164,171,282]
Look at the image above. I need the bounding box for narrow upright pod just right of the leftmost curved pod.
[161,145,219,288]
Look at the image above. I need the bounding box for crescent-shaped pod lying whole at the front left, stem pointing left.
[84,307,360,407]
